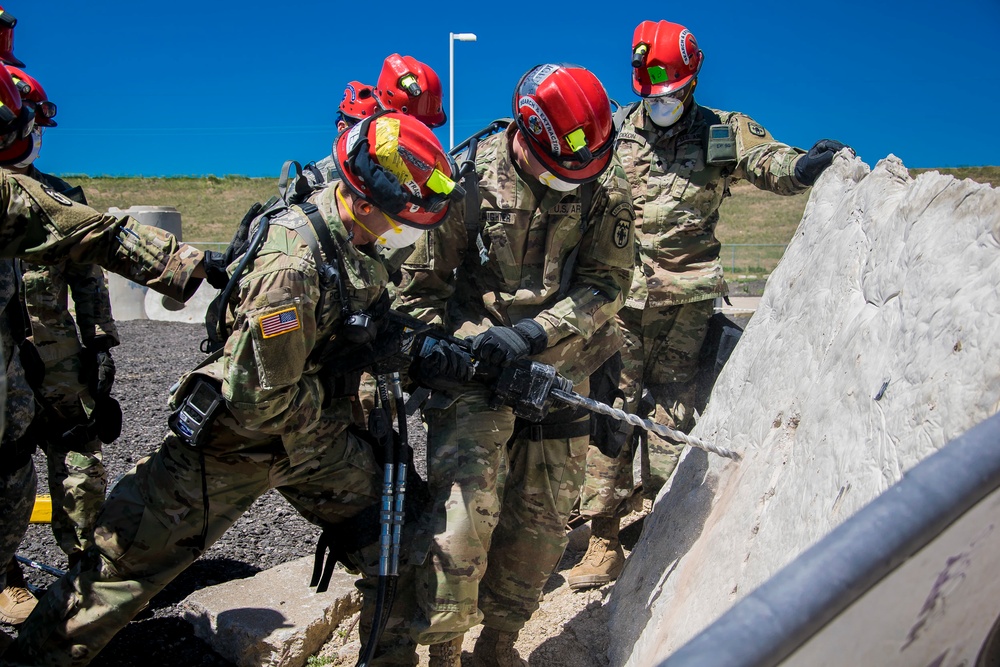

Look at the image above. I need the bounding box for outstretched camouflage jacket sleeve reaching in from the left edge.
[0,169,203,301]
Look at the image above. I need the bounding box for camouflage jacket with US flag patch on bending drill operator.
[172,184,389,465]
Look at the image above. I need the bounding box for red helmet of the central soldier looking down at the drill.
[514,64,615,183]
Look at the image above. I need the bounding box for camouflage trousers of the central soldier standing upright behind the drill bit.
[411,383,589,644]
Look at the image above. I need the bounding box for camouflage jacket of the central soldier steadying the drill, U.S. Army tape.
[397,126,635,382]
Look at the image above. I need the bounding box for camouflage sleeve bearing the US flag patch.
[222,253,324,435]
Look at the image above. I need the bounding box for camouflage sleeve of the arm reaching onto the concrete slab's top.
[728,113,806,195]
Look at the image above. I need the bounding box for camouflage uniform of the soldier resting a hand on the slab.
[580,104,806,516]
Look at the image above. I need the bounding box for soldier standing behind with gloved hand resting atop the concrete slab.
[567,21,844,589]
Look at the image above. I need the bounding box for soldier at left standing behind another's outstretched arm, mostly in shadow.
[0,66,121,620]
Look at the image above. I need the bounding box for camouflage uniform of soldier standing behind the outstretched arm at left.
[24,167,119,560]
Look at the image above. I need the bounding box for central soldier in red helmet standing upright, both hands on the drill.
[397,65,634,667]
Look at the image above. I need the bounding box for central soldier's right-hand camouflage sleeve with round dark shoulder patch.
[535,170,635,347]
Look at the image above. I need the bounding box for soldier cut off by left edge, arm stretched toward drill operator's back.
[0,58,204,632]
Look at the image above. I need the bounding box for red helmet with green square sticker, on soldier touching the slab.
[632,21,705,97]
